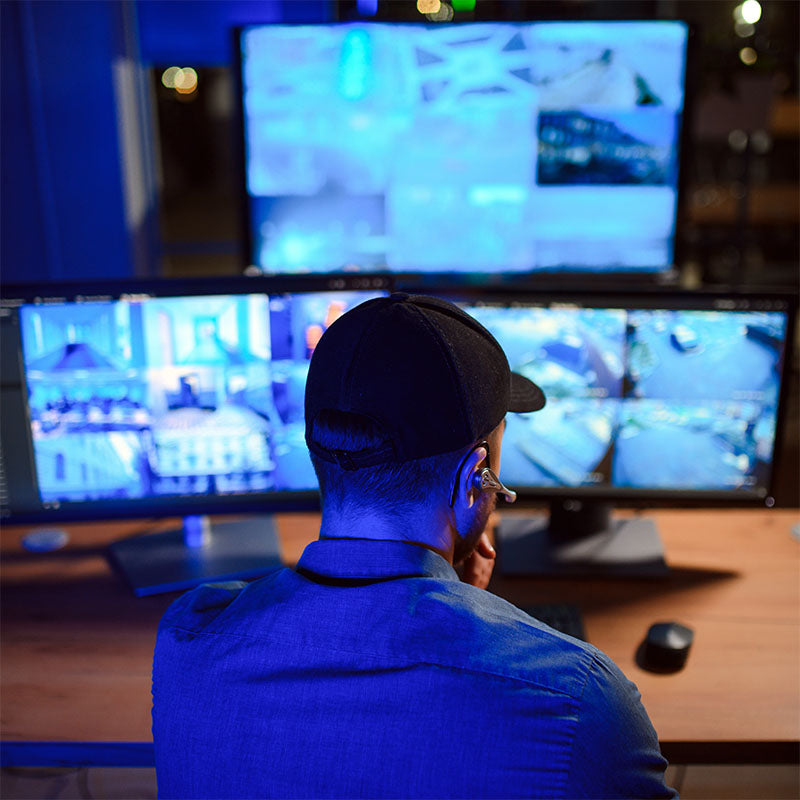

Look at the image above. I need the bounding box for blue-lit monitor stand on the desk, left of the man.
[108,515,282,597]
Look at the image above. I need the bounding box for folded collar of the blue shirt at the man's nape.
[297,538,458,581]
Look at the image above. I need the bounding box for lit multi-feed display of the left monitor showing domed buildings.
[20,292,378,503]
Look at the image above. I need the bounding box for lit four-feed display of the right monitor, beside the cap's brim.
[465,306,787,496]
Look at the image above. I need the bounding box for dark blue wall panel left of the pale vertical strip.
[0,2,134,280]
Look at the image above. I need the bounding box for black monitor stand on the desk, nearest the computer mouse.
[497,500,669,578]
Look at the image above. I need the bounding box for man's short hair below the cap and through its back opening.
[311,410,463,515]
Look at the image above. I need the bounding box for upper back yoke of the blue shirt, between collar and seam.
[155,569,622,697]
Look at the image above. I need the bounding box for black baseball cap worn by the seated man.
[305,292,545,469]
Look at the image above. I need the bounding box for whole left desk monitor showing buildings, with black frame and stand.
[0,276,388,593]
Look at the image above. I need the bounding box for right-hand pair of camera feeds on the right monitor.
[614,311,786,488]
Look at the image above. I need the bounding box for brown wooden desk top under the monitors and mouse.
[0,510,800,765]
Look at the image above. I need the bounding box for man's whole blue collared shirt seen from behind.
[153,539,675,798]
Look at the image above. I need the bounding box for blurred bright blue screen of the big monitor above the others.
[239,21,688,276]
